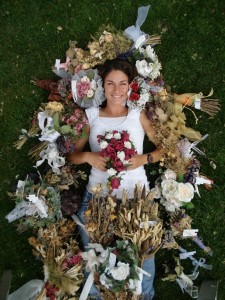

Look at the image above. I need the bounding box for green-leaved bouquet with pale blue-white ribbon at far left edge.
[6,176,62,232]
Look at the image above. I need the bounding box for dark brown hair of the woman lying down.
[98,58,137,85]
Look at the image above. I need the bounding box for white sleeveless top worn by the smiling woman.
[86,107,149,199]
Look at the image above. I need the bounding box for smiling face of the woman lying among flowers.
[104,70,129,104]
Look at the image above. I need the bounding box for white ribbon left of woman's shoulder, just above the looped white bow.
[38,112,60,143]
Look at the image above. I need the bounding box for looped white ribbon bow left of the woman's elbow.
[34,143,65,174]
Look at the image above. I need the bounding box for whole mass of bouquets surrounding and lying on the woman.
[6,7,220,299]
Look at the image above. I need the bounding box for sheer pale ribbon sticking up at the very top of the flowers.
[124,5,150,44]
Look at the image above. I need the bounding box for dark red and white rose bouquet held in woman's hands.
[97,130,137,189]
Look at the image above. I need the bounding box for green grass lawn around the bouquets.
[0,0,225,300]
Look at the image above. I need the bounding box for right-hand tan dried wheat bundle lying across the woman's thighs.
[115,185,164,261]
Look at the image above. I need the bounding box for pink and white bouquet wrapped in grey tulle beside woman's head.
[71,69,105,108]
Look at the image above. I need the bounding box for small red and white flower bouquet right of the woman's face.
[127,76,152,110]
